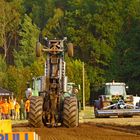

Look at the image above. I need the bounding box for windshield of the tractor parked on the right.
[105,85,126,96]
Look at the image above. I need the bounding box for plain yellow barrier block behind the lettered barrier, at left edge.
[0,120,12,133]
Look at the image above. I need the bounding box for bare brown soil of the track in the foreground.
[13,123,140,140]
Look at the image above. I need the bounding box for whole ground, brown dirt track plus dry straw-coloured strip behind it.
[13,107,140,140]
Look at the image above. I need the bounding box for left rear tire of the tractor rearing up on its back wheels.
[28,96,43,128]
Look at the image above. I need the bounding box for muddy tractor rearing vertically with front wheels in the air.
[26,38,79,127]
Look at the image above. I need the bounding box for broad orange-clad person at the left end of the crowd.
[1,99,10,119]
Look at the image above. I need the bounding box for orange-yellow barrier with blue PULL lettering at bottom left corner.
[0,132,40,140]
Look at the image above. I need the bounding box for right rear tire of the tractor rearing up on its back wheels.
[63,97,79,127]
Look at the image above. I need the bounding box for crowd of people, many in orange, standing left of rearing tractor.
[0,97,30,120]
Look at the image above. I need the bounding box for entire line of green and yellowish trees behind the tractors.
[0,0,140,101]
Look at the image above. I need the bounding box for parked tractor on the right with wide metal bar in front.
[94,81,140,118]
